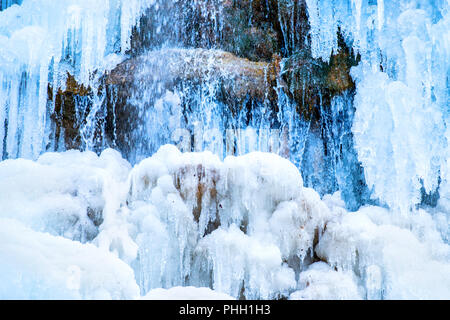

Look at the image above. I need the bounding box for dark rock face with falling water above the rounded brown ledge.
[126,0,283,61]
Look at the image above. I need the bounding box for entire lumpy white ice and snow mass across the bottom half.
[0,145,450,299]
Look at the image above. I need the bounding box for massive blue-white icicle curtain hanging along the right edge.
[307,0,450,213]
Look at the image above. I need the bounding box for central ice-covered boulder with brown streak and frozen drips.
[127,145,331,298]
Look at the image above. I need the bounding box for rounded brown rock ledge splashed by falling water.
[106,49,275,101]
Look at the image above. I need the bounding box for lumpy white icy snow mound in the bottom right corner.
[317,207,450,299]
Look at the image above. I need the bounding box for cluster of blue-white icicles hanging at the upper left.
[0,0,153,159]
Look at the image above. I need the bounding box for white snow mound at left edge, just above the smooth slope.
[0,149,130,242]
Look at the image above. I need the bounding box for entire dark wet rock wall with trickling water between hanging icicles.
[49,0,365,210]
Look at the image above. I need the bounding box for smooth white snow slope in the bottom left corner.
[0,218,139,300]
